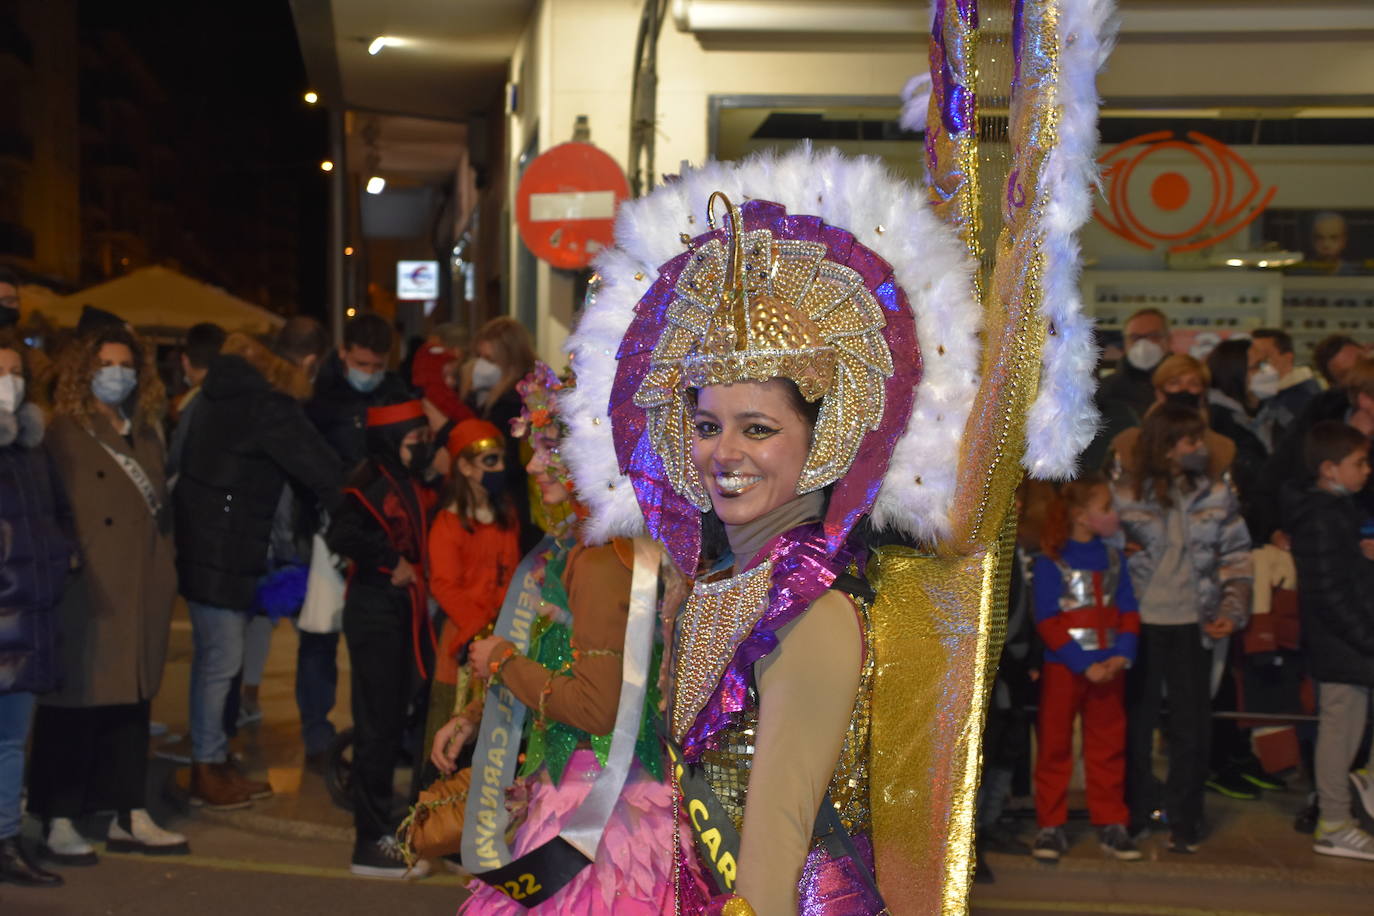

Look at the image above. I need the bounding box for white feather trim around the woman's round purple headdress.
[559,146,981,541]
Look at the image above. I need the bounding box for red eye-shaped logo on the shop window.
[1094,130,1278,253]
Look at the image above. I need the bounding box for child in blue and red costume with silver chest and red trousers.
[1031,474,1140,861]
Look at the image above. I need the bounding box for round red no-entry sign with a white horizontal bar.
[515,143,629,271]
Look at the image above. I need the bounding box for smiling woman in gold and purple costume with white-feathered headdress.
[562,0,1106,916]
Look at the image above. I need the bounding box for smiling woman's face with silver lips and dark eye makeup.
[691,379,811,525]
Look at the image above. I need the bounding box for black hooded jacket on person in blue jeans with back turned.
[174,354,344,611]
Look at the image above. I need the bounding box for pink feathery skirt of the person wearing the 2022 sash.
[458,750,673,916]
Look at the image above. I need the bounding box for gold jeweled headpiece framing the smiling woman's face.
[635,191,893,511]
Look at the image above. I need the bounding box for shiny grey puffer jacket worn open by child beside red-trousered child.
[1112,428,1254,629]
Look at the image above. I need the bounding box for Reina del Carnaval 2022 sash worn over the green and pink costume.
[462,538,662,906]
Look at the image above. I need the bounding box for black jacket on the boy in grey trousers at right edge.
[1285,486,1374,687]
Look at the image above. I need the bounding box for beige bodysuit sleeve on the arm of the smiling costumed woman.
[735,592,863,916]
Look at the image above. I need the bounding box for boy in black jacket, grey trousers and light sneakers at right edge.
[1290,420,1374,861]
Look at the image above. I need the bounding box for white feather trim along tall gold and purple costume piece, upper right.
[1022,0,1117,479]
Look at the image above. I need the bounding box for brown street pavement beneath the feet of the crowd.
[0,601,1374,916]
